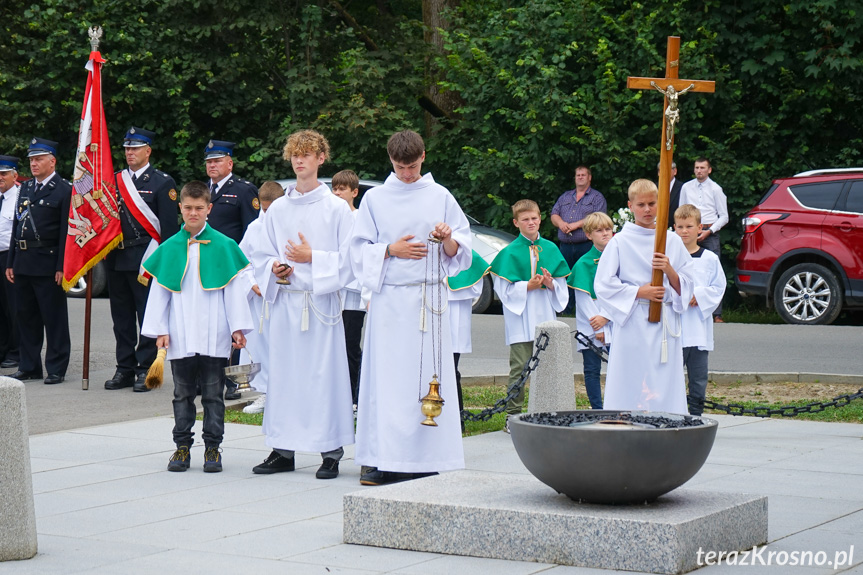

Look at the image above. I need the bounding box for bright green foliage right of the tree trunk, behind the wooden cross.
[436,0,863,245]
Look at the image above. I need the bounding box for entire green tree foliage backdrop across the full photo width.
[0,0,863,254]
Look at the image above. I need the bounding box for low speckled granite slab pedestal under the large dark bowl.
[344,471,767,573]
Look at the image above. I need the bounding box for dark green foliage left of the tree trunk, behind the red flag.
[0,0,425,182]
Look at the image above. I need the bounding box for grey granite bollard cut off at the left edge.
[0,377,36,561]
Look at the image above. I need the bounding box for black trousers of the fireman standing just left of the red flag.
[15,274,72,375]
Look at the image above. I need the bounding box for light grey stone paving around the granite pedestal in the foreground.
[0,416,863,575]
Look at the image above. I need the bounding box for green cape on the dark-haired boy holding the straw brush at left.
[143,224,249,293]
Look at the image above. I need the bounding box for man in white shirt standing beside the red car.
[680,156,728,323]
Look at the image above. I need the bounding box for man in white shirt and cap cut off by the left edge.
[0,156,20,368]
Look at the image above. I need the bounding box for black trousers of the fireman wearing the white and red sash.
[108,270,157,375]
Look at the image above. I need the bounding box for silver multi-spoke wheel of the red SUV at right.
[773,263,842,325]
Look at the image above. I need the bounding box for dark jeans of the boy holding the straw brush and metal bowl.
[171,354,228,447]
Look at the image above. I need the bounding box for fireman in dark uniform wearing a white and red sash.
[105,126,180,392]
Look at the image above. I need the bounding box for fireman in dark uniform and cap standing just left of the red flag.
[6,138,72,384]
